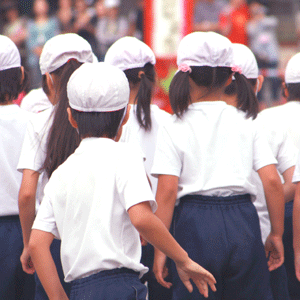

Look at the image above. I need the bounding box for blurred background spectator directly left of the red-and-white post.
[128,0,145,41]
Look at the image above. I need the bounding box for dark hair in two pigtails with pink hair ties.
[169,66,258,119]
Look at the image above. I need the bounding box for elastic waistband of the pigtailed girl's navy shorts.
[180,194,251,205]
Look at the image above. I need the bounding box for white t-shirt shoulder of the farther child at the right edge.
[261,101,300,151]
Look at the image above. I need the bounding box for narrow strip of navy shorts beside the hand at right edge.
[283,201,300,300]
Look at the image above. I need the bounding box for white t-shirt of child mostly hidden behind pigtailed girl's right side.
[252,112,298,243]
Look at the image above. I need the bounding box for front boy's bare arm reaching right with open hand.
[128,202,216,297]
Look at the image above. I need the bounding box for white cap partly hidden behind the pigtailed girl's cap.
[232,44,258,79]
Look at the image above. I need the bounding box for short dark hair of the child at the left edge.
[0,67,28,104]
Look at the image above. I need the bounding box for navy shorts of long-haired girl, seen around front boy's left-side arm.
[34,239,71,300]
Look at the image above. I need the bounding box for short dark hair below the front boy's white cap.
[71,108,125,139]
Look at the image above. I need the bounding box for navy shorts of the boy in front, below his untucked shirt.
[70,268,147,300]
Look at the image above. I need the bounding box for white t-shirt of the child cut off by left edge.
[0,104,30,216]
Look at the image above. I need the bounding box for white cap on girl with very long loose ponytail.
[40,33,93,75]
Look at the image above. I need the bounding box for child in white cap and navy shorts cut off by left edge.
[0,35,34,300]
